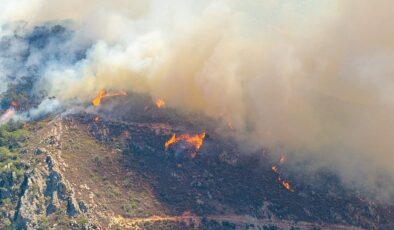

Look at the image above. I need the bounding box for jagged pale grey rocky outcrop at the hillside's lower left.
[14,121,87,229]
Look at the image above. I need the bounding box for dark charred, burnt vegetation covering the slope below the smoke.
[62,95,391,229]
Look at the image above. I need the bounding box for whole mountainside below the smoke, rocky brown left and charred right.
[0,94,394,229]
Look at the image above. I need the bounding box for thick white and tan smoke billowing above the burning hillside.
[0,0,394,200]
